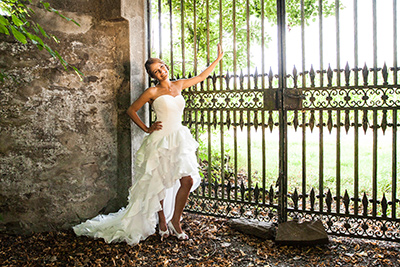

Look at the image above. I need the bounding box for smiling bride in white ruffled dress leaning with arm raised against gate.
[73,44,223,245]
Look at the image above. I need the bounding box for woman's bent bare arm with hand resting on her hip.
[126,88,162,133]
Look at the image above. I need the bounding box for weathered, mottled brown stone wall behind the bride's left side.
[0,0,136,233]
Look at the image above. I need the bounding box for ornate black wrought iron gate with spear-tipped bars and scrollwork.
[152,0,400,241]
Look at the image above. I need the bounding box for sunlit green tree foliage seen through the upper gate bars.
[152,0,342,76]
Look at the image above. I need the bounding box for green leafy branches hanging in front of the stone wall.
[0,0,83,81]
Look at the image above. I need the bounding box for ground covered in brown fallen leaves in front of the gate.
[0,213,400,267]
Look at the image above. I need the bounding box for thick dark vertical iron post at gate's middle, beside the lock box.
[277,0,287,222]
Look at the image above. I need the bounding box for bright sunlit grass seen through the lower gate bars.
[200,128,400,199]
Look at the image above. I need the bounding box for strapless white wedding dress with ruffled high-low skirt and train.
[73,95,200,245]
